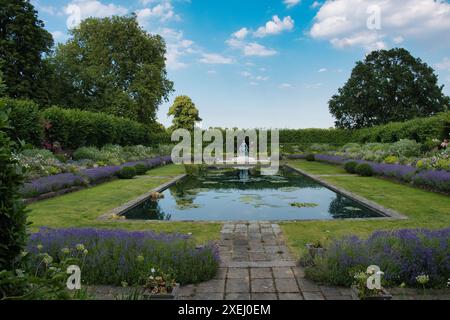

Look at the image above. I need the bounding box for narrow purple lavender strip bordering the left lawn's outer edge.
[21,156,172,198]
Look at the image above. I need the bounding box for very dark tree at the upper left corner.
[0,0,53,103]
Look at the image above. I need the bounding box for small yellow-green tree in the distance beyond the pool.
[167,96,202,131]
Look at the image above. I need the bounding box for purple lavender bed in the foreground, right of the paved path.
[306,228,450,288]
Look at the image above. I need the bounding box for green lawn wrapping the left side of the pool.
[28,165,221,242]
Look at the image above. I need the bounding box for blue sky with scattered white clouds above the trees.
[32,0,450,128]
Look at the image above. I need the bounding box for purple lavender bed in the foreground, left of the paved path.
[27,228,219,286]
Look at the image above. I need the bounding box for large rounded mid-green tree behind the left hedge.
[51,15,173,123]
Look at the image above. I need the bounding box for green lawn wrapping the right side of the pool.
[281,161,450,254]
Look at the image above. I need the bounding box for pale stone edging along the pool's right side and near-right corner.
[284,164,408,220]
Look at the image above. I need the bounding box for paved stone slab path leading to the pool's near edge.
[180,222,354,300]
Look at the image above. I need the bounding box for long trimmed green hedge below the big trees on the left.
[0,98,170,149]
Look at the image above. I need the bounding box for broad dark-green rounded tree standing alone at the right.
[329,48,450,128]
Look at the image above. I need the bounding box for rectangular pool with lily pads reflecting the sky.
[123,168,382,221]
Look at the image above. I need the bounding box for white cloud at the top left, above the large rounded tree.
[64,0,128,29]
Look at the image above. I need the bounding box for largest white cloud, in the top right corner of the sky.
[310,0,450,50]
